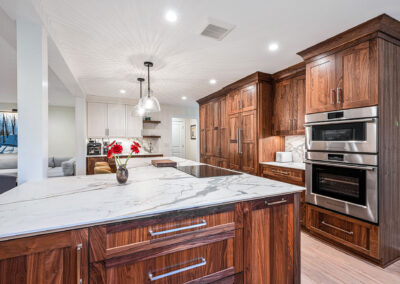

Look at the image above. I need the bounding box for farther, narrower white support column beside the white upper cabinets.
[75,97,86,175]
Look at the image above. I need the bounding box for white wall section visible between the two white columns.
[49,106,76,157]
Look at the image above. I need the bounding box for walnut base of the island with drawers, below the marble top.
[0,193,300,284]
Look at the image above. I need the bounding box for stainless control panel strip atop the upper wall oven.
[305,106,378,123]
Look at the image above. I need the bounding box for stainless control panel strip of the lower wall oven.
[306,152,378,166]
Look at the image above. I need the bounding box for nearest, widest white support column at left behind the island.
[17,18,48,184]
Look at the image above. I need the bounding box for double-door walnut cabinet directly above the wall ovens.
[306,31,378,113]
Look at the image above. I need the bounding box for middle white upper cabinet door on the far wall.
[107,104,126,137]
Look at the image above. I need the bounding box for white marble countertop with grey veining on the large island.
[0,158,304,240]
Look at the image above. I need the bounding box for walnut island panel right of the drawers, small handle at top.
[244,194,300,283]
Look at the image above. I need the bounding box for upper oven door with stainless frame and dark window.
[305,118,378,153]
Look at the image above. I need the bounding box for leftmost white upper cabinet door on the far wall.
[87,103,107,138]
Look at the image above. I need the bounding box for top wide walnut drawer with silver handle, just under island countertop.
[89,205,235,262]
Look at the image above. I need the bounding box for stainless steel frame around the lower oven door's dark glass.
[306,163,379,223]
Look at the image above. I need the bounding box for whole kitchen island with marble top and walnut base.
[0,158,303,283]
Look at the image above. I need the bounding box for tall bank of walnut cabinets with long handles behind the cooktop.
[198,72,272,174]
